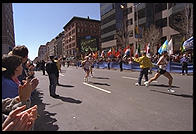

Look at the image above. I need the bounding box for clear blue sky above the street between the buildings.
[13,3,100,60]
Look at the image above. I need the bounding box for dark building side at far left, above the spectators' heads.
[2,3,15,54]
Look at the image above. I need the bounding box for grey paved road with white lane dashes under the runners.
[33,67,193,131]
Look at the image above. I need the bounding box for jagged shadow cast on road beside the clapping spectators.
[31,89,59,131]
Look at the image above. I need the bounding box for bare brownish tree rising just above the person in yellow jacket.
[140,25,161,53]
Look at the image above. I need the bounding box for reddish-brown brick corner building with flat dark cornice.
[63,17,100,58]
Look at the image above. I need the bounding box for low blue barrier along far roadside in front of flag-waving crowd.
[94,62,193,73]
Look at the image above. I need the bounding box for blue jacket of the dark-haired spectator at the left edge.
[2,76,18,99]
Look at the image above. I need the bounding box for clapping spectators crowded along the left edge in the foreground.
[2,45,39,131]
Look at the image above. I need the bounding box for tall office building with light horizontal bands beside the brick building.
[100,3,126,50]
